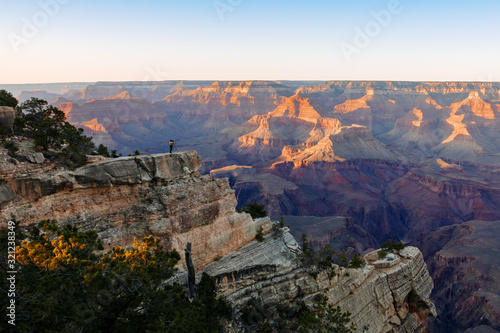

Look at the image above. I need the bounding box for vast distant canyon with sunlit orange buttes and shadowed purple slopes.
[0,81,500,332]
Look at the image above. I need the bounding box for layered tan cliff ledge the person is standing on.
[0,151,270,268]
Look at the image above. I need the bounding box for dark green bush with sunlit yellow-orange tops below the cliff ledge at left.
[0,221,231,333]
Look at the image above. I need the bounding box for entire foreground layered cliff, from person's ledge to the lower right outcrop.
[0,147,436,333]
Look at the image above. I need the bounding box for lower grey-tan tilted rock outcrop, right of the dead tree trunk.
[200,228,435,333]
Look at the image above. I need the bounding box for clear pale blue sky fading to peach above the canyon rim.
[0,0,500,84]
